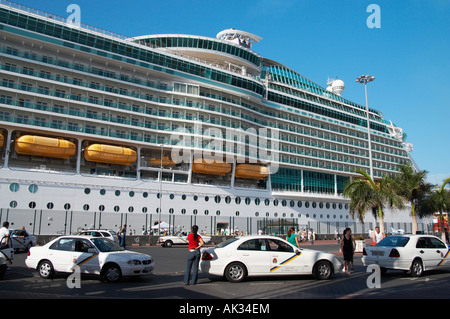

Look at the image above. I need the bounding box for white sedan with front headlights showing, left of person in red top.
[25,236,155,282]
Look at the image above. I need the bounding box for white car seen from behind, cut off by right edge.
[362,235,450,277]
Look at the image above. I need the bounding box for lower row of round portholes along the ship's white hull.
[9,200,348,219]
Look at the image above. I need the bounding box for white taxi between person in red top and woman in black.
[199,236,341,282]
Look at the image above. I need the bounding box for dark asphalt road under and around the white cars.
[0,244,450,304]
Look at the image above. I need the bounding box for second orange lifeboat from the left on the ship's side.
[84,144,137,165]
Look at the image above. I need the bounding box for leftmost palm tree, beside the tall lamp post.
[343,169,403,233]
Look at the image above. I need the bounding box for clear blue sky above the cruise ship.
[10,0,450,184]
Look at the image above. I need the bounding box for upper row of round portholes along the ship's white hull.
[9,183,348,209]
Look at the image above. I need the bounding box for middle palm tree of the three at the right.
[394,164,431,234]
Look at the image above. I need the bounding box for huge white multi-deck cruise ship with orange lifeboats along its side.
[0,0,426,234]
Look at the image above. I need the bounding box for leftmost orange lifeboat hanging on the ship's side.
[14,135,77,159]
